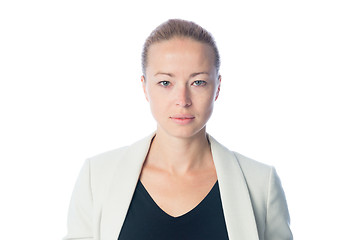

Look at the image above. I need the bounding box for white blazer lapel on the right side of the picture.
[209,136,259,240]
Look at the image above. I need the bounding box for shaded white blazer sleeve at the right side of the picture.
[265,168,293,240]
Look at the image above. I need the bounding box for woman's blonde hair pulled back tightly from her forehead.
[141,19,220,76]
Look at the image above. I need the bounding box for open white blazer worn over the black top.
[64,134,293,240]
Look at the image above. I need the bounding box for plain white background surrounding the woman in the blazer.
[0,0,360,240]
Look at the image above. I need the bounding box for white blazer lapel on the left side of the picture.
[100,134,154,240]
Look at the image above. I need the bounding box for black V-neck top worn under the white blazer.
[118,180,229,240]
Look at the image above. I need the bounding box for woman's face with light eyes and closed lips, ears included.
[142,38,221,138]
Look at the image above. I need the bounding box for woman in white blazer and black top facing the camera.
[64,20,292,240]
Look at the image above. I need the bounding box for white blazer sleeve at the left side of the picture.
[63,159,94,240]
